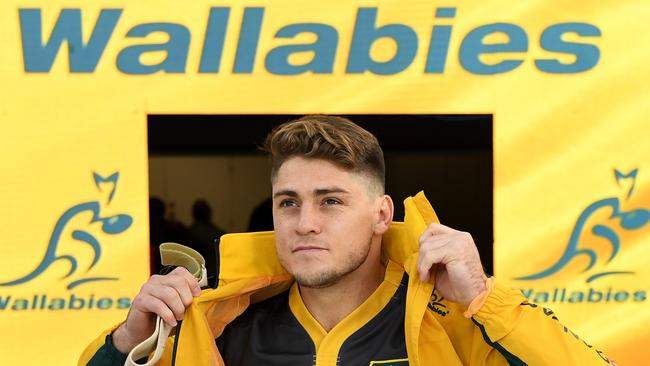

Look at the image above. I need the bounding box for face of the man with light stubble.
[273,157,378,288]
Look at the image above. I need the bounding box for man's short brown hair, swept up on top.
[262,115,385,194]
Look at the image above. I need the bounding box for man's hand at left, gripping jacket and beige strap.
[113,267,201,354]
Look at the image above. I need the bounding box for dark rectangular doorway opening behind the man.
[148,114,493,273]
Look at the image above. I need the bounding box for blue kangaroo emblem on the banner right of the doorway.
[515,169,650,283]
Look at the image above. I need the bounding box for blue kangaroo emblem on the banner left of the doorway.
[0,172,133,290]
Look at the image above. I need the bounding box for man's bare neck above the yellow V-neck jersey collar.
[299,253,386,332]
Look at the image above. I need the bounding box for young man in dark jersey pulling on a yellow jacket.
[80,116,609,366]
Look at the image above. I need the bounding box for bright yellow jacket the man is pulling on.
[79,193,607,366]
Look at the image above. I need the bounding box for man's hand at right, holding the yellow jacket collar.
[418,223,487,307]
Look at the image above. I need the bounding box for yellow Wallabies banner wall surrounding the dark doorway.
[0,0,650,365]
